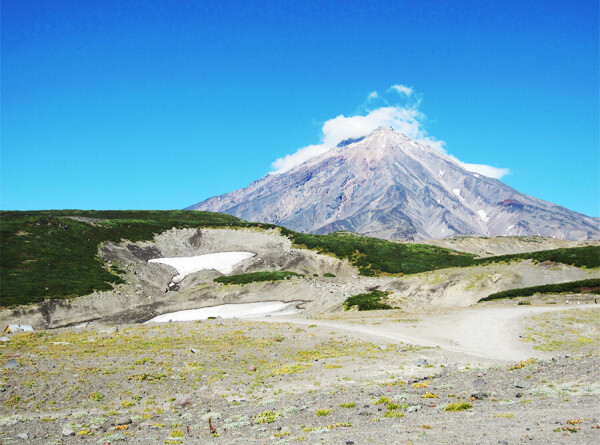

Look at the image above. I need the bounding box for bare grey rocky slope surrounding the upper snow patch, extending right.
[0,228,599,328]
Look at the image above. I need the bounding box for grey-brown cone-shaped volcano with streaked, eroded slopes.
[188,127,600,240]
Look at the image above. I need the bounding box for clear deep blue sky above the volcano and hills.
[0,0,600,216]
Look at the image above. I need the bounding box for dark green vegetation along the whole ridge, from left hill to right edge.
[0,210,600,307]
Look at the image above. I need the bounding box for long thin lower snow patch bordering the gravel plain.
[146,301,301,323]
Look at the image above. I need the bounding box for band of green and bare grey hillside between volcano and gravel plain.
[0,211,600,327]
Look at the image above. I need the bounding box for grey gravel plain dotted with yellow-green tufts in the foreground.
[0,309,600,444]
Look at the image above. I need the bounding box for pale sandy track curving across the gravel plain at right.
[260,304,600,361]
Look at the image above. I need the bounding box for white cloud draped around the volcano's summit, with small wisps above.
[272,85,510,179]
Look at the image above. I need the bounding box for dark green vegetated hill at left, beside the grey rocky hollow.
[0,210,274,306]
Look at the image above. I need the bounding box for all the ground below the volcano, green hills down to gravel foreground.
[0,211,600,444]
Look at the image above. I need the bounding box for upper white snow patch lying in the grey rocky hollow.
[148,252,256,283]
